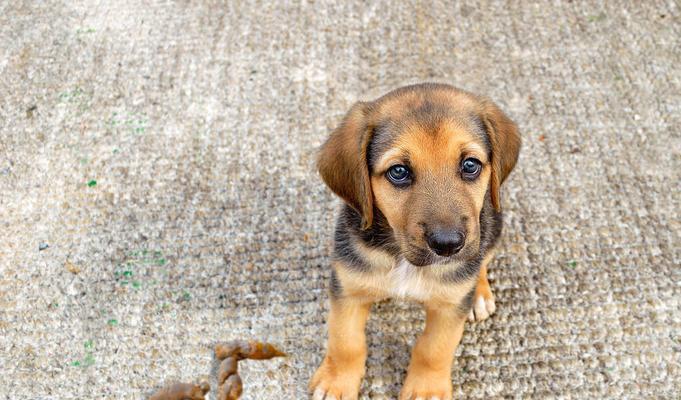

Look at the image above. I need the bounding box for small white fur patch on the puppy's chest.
[387,260,435,301]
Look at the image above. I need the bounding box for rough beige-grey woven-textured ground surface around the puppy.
[0,0,681,399]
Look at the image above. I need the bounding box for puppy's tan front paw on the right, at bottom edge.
[400,368,452,400]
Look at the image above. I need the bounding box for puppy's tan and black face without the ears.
[368,115,491,266]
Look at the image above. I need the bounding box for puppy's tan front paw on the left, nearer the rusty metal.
[309,358,364,400]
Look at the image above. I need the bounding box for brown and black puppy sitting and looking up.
[310,84,520,400]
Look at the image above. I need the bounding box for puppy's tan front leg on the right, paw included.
[400,305,466,400]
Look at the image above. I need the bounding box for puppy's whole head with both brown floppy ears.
[318,84,520,266]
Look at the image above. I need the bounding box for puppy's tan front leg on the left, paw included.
[310,297,371,400]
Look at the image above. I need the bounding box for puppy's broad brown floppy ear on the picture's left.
[317,102,374,229]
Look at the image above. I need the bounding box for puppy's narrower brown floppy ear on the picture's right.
[481,100,520,212]
